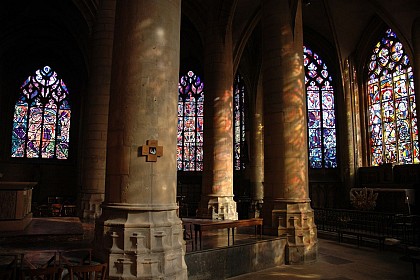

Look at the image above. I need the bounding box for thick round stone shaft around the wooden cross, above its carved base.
[105,0,180,206]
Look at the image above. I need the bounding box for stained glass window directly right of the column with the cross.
[177,71,204,171]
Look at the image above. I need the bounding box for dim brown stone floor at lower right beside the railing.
[229,239,412,280]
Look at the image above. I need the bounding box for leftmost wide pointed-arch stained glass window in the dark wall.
[11,66,71,159]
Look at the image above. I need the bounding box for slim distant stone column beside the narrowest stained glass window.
[249,77,264,218]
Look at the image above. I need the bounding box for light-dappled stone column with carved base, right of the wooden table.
[262,0,317,264]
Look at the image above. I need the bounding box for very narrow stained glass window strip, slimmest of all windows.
[233,74,246,170]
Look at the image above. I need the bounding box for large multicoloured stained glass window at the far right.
[367,29,420,165]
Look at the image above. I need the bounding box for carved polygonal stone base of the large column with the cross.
[94,205,188,279]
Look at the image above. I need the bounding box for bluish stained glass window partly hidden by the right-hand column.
[303,46,337,168]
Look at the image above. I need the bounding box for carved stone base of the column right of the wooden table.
[272,201,318,264]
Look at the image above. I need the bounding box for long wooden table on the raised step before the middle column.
[191,218,263,249]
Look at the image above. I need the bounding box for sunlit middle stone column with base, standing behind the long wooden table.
[197,0,238,220]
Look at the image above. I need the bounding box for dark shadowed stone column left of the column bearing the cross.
[80,0,115,220]
